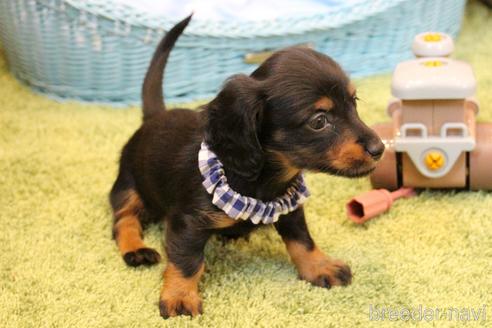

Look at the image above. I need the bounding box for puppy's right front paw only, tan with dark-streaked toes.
[301,259,352,288]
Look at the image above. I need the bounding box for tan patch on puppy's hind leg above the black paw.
[114,215,145,255]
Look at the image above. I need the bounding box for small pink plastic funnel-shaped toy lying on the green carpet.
[347,188,416,224]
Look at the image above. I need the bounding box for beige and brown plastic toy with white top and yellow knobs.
[371,33,492,190]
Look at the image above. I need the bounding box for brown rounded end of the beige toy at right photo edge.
[469,123,492,190]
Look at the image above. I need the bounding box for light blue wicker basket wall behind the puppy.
[0,0,465,104]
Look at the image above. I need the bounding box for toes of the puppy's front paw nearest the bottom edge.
[159,292,203,319]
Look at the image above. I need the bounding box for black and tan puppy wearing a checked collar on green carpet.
[110,16,384,318]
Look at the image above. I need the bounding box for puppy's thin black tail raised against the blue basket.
[142,14,193,121]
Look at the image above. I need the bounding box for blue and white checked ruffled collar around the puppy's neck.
[198,142,309,224]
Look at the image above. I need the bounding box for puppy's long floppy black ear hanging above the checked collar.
[205,74,264,181]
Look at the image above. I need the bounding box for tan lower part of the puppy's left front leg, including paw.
[159,263,205,317]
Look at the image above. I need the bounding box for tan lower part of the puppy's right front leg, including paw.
[285,241,352,287]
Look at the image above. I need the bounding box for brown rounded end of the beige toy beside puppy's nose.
[371,123,398,190]
